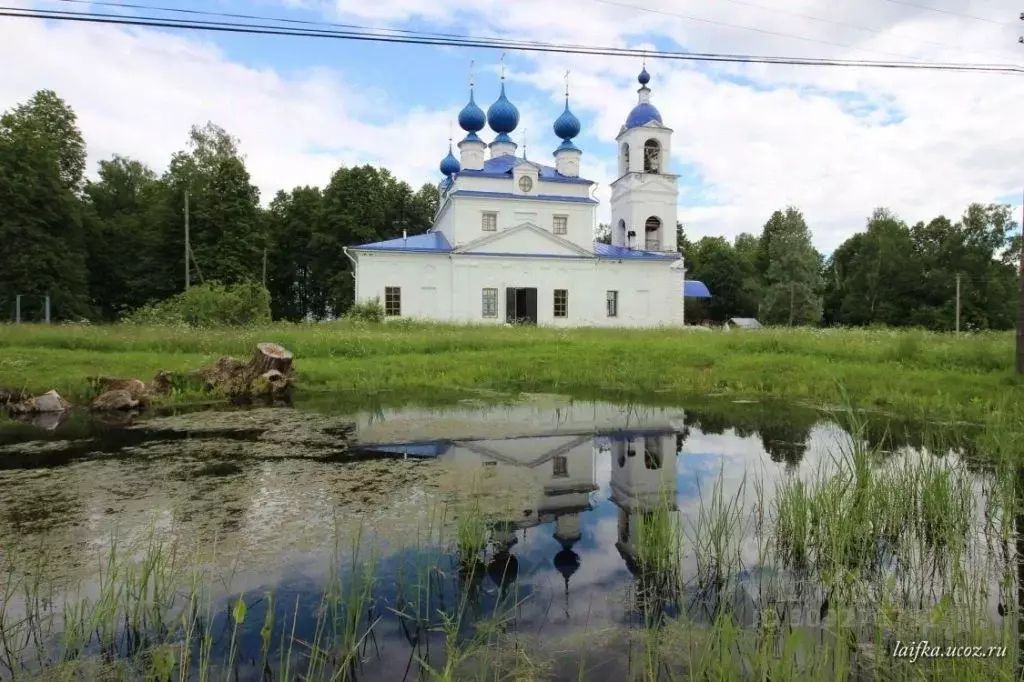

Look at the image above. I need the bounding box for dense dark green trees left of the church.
[0,90,437,322]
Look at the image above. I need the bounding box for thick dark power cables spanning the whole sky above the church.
[0,6,1024,74]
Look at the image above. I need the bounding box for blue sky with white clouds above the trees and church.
[0,0,1024,252]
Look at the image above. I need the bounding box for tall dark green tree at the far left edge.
[0,90,91,319]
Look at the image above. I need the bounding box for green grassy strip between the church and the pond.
[0,323,1024,422]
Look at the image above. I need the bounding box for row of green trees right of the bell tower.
[681,204,1021,331]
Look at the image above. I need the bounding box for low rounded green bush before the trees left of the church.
[125,283,270,327]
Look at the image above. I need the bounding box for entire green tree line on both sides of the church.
[0,90,1021,330]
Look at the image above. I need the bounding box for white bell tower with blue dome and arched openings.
[611,65,679,252]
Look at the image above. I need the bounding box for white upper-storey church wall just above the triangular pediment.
[445,197,596,250]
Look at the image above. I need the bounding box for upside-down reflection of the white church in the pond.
[356,424,685,590]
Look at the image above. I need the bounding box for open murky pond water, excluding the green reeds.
[0,396,999,680]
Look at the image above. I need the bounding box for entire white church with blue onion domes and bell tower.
[346,68,709,327]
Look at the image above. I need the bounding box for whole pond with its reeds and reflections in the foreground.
[0,396,1021,681]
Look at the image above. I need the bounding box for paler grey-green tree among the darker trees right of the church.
[759,207,821,325]
